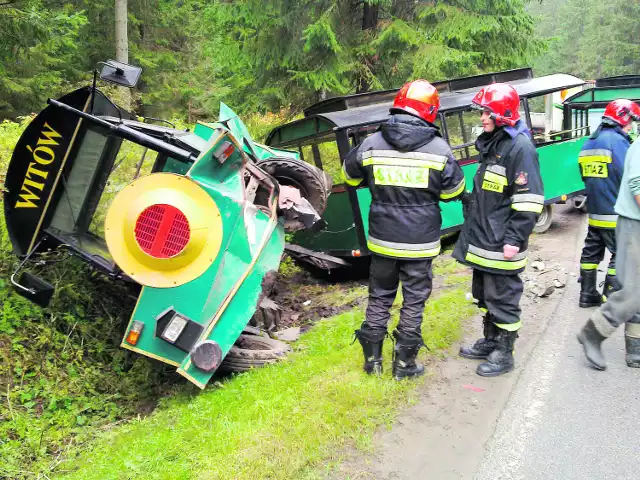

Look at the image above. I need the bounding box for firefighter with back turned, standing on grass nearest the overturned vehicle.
[343,80,465,380]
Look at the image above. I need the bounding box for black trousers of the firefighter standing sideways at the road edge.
[471,268,524,331]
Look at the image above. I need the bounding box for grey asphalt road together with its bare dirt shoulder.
[330,207,640,480]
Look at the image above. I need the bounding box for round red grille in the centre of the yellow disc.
[135,204,191,258]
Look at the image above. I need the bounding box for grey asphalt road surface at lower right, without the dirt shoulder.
[474,234,640,480]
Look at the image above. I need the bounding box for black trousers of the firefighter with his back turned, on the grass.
[361,254,433,340]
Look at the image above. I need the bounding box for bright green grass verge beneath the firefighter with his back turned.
[53,289,474,480]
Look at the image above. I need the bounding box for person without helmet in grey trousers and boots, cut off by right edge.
[578,122,640,370]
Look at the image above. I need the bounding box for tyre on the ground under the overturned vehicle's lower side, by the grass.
[219,333,291,373]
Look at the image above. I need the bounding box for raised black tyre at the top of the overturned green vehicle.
[258,157,332,215]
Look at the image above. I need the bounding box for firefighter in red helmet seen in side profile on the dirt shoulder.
[453,83,544,376]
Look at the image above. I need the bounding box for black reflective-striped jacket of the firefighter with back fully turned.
[343,114,465,259]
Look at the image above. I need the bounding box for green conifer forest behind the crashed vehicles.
[0,0,640,122]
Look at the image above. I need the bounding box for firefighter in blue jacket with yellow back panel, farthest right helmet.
[578,99,640,308]
